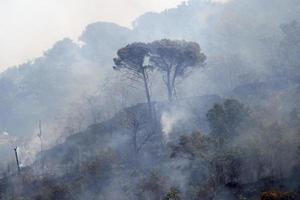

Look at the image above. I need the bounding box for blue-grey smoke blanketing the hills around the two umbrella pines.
[0,0,299,199]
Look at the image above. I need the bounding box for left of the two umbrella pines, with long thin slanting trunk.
[113,43,152,116]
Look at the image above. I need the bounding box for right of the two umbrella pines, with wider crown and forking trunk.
[148,39,206,101]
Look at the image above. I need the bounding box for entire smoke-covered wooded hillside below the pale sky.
[0,0,300,200]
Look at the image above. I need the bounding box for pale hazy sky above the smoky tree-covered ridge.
[0,0,186,71]
